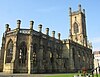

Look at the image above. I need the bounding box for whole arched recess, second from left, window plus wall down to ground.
[18,41,28,72]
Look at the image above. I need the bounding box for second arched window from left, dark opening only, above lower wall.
[18,42,27,65]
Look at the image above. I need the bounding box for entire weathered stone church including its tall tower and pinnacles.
[0,5,93,74]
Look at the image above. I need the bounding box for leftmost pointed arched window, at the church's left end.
[6,40,13,63]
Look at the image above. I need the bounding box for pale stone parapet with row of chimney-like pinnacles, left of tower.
[5,20,61,40]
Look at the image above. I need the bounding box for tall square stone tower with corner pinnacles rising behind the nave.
[69,5,87,47]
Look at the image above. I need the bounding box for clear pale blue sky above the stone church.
[0,0,100,51]
